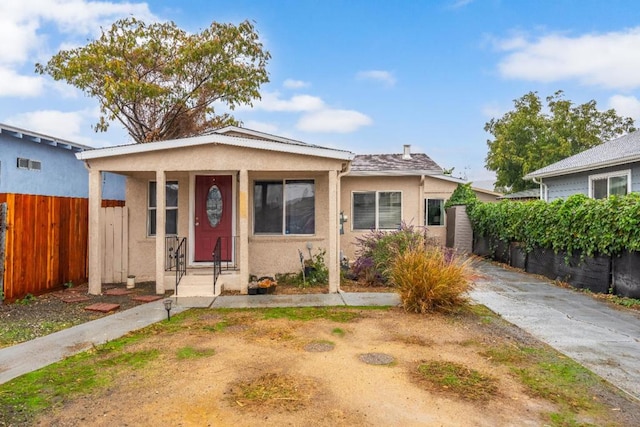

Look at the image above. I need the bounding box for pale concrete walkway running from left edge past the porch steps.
[0,293,400,384]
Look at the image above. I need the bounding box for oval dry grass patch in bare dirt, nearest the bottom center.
[230,373,317,411]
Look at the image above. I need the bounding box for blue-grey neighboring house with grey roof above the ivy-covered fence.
[524,131,640,202]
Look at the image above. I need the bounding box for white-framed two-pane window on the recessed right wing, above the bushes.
[351,191,402,230]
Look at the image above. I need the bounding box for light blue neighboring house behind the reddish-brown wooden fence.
[0,123,124,200]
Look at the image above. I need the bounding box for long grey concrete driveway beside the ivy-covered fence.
[471,261,640,400]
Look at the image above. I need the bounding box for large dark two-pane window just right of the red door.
[253,179,316,235]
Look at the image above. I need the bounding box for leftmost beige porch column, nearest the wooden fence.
[89,169,102,295]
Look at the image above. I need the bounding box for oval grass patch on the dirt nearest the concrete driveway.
[418,361,498,401]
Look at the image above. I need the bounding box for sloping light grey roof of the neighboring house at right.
[524,131,640,179]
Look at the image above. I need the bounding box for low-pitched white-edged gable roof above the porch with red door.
[77,126,354,160]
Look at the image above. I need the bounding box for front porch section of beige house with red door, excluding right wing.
[77,126,353,296]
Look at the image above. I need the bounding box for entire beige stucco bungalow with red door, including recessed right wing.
[77,126,497,296]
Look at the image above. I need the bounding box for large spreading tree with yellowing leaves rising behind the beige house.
[36,18,271,143]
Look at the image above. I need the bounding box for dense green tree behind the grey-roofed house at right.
[484,91,635,192]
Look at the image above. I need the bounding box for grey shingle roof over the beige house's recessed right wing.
[349,153,442,176]
